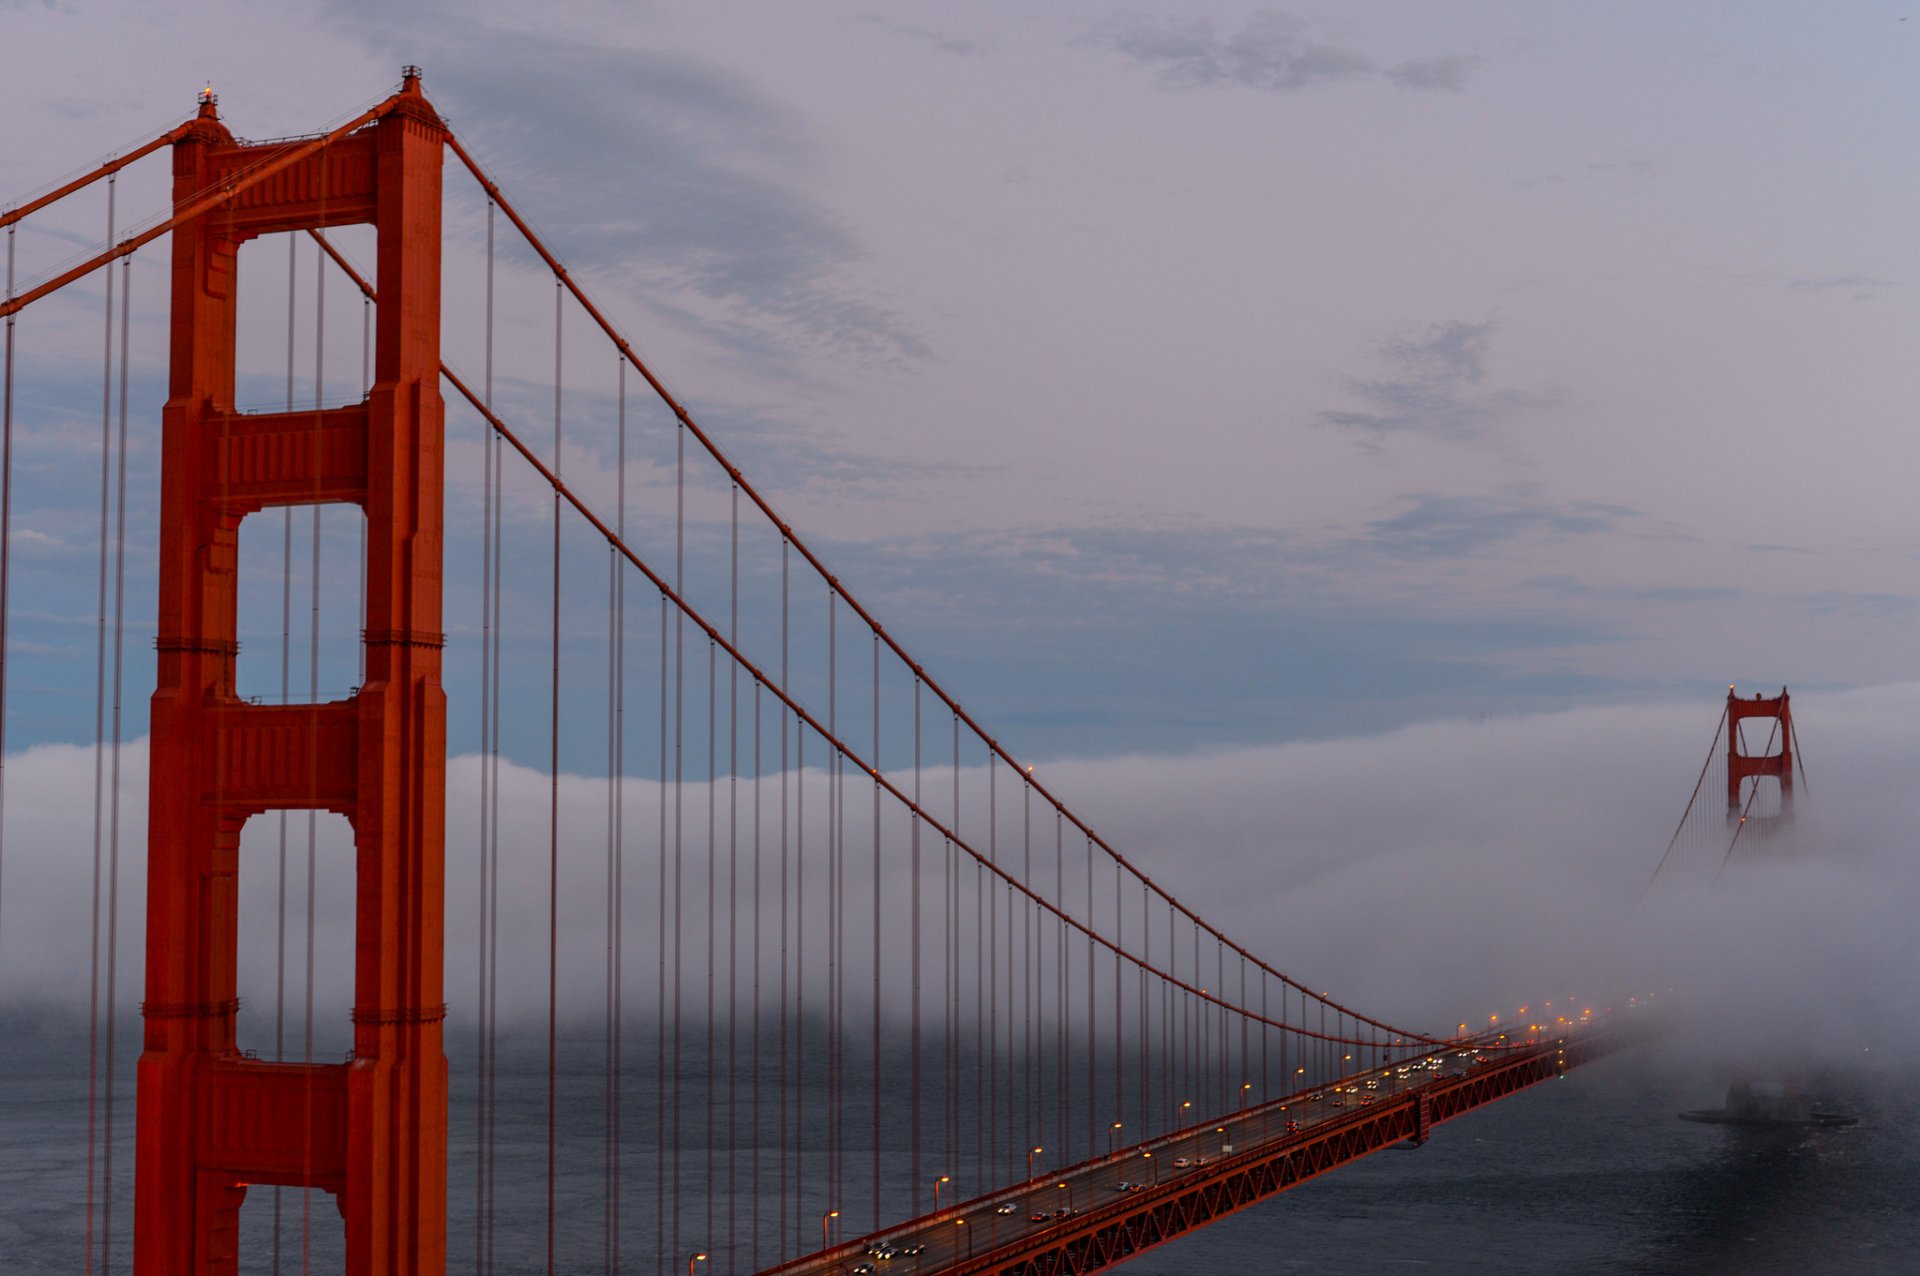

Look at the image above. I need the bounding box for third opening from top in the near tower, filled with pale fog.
[234,810,355,1063]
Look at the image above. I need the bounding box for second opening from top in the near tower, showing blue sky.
[234,503,367,704]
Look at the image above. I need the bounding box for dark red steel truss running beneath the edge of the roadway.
[906,1027,1638,1276]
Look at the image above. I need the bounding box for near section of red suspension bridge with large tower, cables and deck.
[0,67,1630,1276]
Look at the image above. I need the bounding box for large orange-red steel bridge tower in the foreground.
[134,67,447,1276]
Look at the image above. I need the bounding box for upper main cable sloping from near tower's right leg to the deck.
[447,132,1446,1046]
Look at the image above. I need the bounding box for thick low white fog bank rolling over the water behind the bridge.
[0,685,1920,1061]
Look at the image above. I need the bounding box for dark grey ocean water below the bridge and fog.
[0,1048,1920,1276]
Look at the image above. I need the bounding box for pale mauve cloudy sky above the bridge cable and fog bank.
[0,0,1920,754]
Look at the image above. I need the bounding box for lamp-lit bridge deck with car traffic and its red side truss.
[764,1019,1638,1276]
